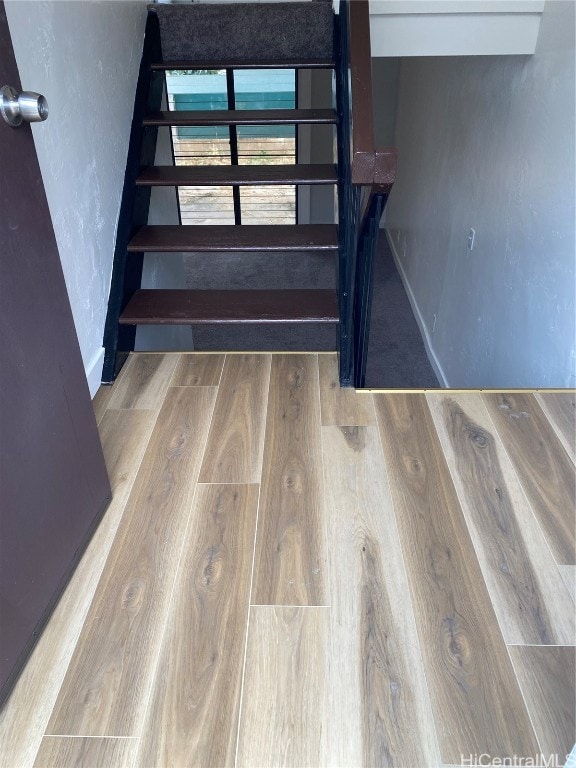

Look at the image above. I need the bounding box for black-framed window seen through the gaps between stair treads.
[166,69,296,225]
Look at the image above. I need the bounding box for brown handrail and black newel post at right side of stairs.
[336,0,396,387]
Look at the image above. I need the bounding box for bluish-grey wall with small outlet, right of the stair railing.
[386,0,576,387]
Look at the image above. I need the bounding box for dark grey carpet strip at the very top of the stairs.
[152,2,333,63]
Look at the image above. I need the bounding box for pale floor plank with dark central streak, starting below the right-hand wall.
[428,394,576,645]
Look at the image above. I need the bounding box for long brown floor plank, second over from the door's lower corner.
[47,387,216,736]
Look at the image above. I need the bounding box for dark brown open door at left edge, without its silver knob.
[0,0,110,701]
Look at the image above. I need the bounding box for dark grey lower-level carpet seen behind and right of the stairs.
[185,233,439,389]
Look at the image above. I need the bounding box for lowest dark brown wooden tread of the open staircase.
[120,289,338,325]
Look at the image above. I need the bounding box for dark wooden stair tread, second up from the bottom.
[128,224,338,253]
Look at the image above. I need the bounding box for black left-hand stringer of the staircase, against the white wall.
[102,11,164,384]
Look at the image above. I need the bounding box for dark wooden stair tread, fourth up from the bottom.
[144,109,338,126]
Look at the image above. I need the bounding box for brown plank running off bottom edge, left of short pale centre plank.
[137,484,258,768]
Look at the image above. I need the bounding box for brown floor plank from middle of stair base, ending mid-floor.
[254,355,327,605]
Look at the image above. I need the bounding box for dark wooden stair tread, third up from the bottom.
[136,165,338,187]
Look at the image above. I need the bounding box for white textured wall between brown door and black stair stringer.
[6,0,146,394]
